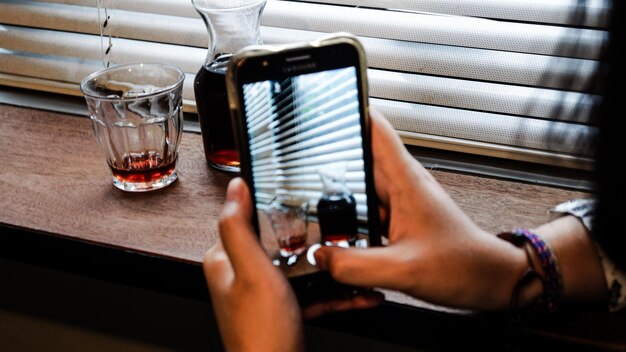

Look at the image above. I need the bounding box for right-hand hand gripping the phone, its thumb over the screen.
[315,111,526,310]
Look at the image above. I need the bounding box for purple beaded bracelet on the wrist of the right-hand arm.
[498,229,563,312]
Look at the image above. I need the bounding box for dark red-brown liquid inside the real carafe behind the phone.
[193,66,239,172]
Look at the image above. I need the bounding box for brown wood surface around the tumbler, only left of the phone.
[0,106,231,262]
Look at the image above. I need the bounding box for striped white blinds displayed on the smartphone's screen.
[243,67,367,234]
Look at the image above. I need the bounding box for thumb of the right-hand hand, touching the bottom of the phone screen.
[314,246,401,289]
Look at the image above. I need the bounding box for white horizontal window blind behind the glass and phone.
[0,0,611,169]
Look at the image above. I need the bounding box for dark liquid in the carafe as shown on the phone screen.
[317,193,358,244]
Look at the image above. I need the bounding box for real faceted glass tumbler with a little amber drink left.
[80,63,185,192]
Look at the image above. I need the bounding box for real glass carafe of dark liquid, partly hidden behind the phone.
[191,0,267,172]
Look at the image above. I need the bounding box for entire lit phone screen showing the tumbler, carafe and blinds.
[243,67,369,277]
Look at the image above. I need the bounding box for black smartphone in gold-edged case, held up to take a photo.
[226,33,381,301]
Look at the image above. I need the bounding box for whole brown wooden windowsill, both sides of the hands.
[0,105,624,350]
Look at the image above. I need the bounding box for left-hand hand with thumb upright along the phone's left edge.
[204,178,304,351]
